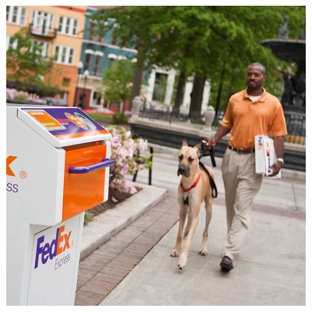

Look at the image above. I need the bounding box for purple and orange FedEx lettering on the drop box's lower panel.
[35,225,72,269]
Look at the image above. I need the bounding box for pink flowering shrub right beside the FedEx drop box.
[109,126,152,194]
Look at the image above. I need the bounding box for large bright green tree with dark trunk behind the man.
[150,6,305,114]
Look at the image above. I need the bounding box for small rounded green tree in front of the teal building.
[102,60,134,103]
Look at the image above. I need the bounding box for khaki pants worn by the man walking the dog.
[221,148,262,261]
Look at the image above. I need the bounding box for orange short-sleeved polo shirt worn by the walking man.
[221,88,287,148]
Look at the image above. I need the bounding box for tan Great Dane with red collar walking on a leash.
[171,139,216,270]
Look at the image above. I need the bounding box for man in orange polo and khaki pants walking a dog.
[206,63,287,272]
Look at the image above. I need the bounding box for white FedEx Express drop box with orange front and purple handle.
[6,104,114,306]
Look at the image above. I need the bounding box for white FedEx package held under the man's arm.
[255,135,281,178]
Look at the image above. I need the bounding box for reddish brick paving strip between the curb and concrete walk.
[75,186,178,305]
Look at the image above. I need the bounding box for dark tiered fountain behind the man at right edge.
[261,15,306,143]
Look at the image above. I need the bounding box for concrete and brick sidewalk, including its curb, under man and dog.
[75,149,306,306]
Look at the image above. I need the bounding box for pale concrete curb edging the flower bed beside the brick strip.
[80,183,168,261]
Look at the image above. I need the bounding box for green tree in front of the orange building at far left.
[6,27,55,88]
